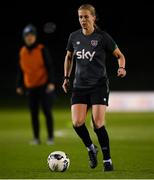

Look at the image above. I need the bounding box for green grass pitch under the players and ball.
[0,108,154,179]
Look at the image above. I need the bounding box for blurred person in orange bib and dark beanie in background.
[16,25,55,145]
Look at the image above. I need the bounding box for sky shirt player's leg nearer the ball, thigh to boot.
[71,104,97,168]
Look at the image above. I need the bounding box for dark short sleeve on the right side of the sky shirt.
[104,32,118,52]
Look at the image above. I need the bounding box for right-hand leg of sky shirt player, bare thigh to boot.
[92,105,113,171]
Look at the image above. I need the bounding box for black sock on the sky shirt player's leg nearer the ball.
[73,124,92,147]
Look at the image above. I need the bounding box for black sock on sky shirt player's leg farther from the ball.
[95,126,111,160]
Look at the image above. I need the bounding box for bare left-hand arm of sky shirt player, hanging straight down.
[62,51,73,93]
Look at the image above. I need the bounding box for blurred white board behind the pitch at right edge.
[108,91,154,112]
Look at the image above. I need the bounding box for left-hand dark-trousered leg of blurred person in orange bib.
[27,90,40,145]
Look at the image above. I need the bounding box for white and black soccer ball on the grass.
[47,151,70,172]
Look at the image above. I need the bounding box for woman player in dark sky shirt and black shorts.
[63,4,126,171]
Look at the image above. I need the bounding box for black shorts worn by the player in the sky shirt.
[71,84,109,106]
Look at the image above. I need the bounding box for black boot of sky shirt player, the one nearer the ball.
[88,146,98,169]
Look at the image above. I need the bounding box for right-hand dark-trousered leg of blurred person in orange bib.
[41,89,54,145]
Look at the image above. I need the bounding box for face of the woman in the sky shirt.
[78,10,96,29]
